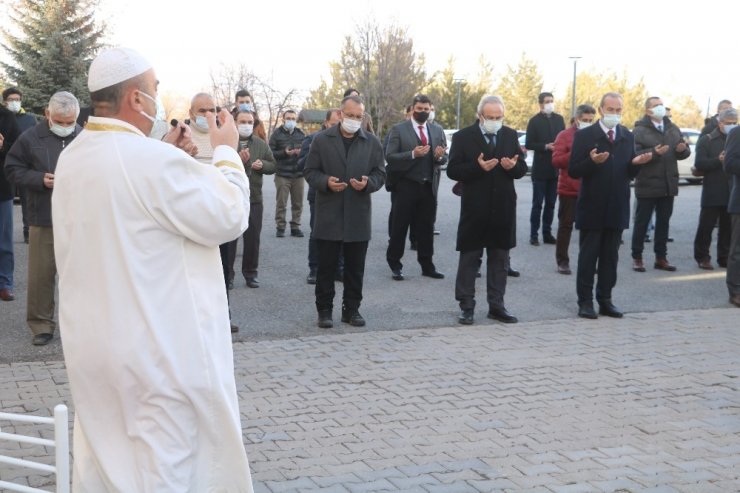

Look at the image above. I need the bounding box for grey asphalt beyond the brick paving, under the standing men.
[0,176,728,363]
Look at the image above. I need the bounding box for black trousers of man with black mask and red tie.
[386,179,435,272]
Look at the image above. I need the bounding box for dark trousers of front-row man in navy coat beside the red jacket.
[576,229,622,304]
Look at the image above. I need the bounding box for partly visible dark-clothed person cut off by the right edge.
[723,127,740,308]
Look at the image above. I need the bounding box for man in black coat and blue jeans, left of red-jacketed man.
[524,92,565,246]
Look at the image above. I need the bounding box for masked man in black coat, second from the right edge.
[694,108,737,270]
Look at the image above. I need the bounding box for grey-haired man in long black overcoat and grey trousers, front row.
[447,96,527,325]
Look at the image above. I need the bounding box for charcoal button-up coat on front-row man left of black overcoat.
[303,125,385,243]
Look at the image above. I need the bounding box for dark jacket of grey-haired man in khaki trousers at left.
[5,120,82,226]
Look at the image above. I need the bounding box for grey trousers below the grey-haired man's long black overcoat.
[455,248,509,310]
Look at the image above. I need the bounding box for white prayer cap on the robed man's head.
[87,47,152,92]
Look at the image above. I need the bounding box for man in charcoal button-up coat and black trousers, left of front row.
[304,96,385,328]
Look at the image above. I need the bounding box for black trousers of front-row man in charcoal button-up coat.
[315,240,368,311]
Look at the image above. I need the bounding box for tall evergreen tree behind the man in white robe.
[0,0,104,112]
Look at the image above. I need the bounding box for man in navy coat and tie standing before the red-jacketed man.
[568,92,652,319]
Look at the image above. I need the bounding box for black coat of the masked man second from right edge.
[694,128,730,207]
